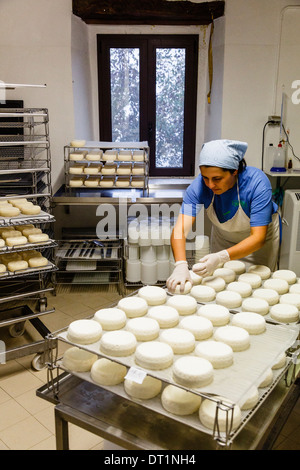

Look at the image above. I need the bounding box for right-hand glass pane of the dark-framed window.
[155,48,185,168]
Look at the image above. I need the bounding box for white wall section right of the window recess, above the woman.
[221,0,300,173]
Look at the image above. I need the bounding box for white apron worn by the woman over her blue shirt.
[206,183,280,271]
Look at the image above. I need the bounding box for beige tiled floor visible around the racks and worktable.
[0,286,300,450]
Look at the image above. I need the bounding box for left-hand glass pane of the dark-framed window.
[110,48,140,142]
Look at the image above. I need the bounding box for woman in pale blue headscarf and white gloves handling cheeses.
[167,140,280,291]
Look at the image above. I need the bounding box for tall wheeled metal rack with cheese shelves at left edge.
[0,104,57,369]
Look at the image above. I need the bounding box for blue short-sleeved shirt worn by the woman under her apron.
[181,166,278,227]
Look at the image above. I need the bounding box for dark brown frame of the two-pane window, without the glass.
[97,34,199,177]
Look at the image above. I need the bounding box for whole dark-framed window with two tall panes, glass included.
[97,35,198,176]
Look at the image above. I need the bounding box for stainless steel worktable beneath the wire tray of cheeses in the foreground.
[37,371,300,450]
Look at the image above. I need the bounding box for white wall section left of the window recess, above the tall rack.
[0,0,74,190]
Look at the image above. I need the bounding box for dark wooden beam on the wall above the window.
[73,0,225,25]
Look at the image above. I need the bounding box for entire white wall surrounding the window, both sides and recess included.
[0,0,300,189]
